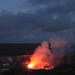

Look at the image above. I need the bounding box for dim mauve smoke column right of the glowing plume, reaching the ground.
[50,38,69,66]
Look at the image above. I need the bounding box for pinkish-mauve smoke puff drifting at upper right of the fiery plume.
[50,37,69,54]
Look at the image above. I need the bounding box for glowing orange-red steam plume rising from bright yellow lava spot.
[28,42,55,69]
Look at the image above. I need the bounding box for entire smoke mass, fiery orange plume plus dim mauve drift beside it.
[27,38,67,69]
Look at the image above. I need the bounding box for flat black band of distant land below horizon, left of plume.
[0,43,40,56]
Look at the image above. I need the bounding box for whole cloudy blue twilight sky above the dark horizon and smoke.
[0,0,75,43]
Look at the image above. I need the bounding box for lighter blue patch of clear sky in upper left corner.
[0,0,25,12]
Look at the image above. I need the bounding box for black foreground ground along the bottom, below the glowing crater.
[3,64,75,75]
